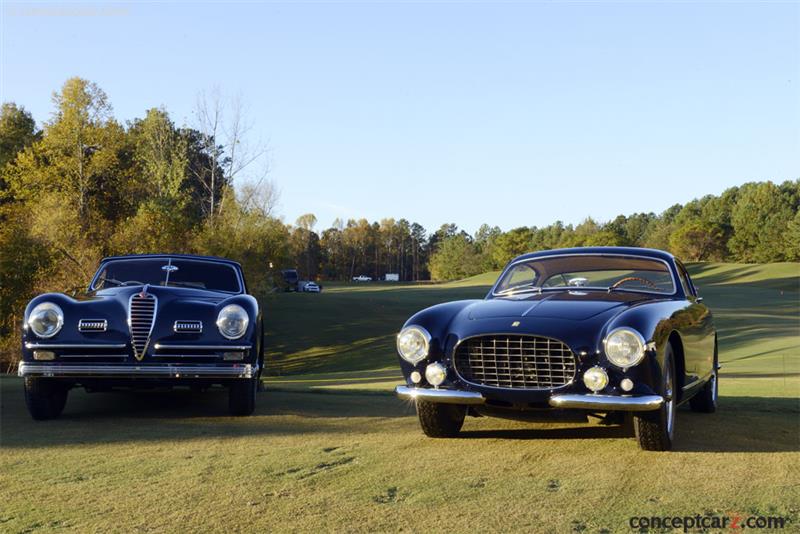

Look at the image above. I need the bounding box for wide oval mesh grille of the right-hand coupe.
[455,335,576,389]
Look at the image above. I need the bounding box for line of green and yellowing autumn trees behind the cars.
[0,78,800,368]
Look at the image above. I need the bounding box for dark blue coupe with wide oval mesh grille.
[396,247,719,450]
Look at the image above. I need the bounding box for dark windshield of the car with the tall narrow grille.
[91,258,242,293]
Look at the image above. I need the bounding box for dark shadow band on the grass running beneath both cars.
[0,379,800,453]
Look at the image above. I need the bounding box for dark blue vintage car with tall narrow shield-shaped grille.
[19,254,264,419]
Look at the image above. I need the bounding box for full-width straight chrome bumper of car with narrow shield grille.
[17,362,258,378]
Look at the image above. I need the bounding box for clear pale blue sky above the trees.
[0,1,800,232]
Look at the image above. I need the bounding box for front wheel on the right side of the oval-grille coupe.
[633,344,675,451]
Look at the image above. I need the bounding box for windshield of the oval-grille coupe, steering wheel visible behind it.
[493,254,675,297]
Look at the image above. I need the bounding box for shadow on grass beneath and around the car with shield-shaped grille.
[0,378,413,448]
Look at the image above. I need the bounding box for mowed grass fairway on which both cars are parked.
[0,264,800,532]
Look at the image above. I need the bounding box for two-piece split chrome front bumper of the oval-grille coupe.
[394,386,664,412]
